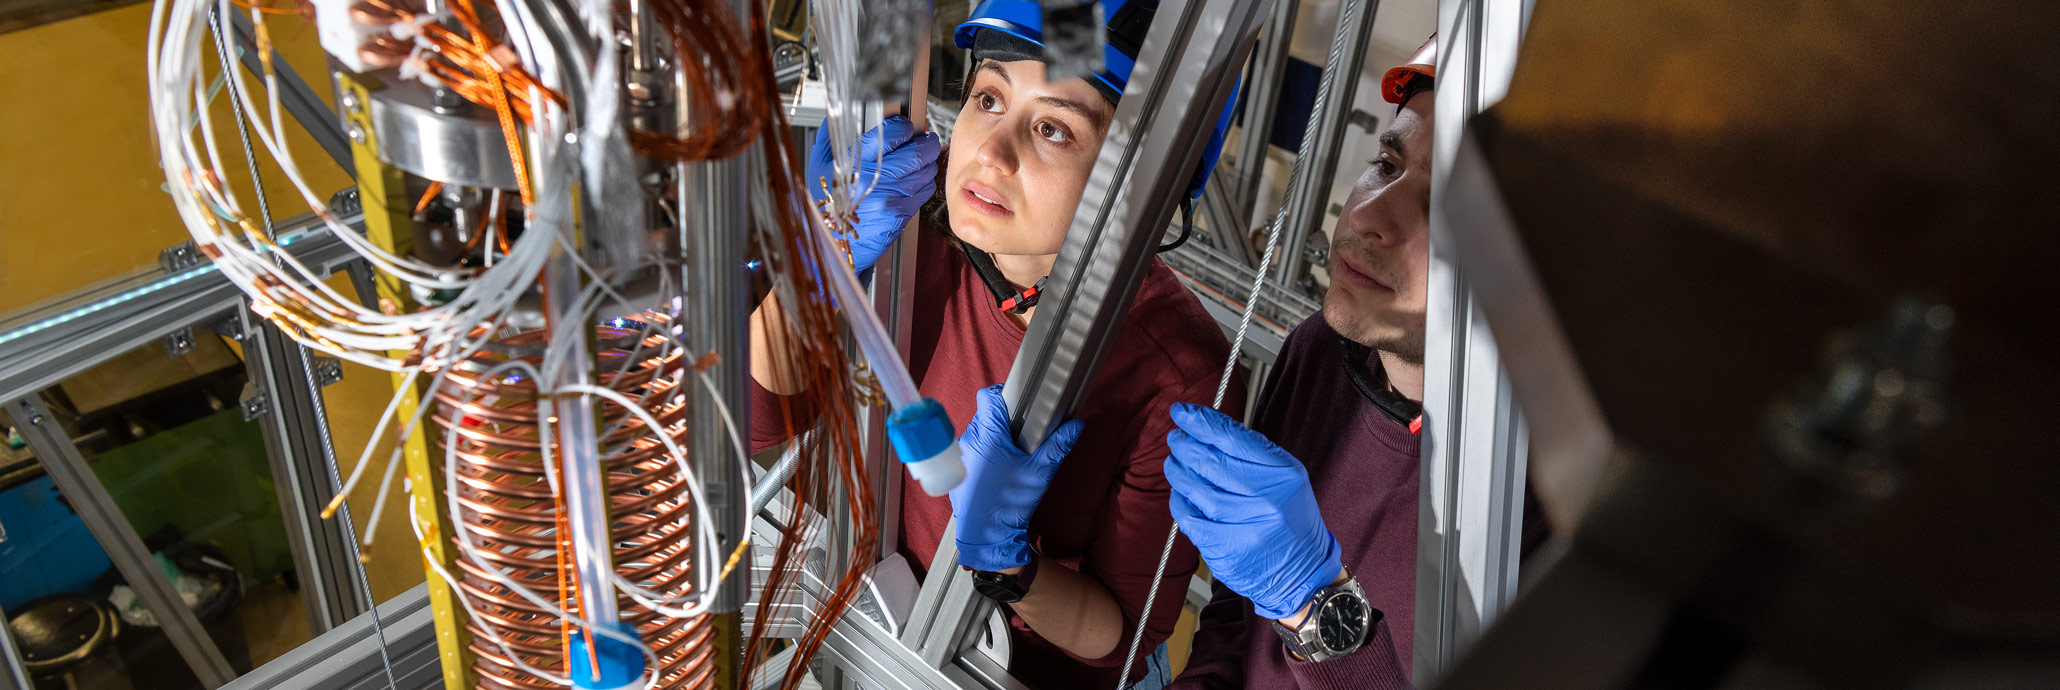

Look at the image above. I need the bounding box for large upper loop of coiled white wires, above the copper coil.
[146,0,552,371]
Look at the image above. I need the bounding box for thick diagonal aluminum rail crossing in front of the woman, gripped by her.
[902,0,1271,667]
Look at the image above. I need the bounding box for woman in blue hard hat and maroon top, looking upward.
[752,0,1242,688]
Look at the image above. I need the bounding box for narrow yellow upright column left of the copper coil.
[336,72,476,690]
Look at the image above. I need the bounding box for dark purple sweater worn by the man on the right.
[1170,313,1421,690]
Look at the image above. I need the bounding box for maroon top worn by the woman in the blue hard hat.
[752,229,1244,688]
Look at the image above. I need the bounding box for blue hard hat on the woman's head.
[952,0,1244,198]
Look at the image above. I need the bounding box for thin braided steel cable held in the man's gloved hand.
[1117,0,1360,690]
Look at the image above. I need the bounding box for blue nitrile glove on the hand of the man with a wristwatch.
[1166,404,1341,620]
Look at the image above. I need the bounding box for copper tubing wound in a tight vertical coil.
[433,315,715,690]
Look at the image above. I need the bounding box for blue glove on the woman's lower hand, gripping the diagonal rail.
[952,385,1082,571]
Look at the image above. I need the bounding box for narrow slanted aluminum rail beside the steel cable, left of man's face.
[1273,0,1380,284]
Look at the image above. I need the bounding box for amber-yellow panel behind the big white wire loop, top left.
[0,0,350,313]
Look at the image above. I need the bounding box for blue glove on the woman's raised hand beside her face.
[803,115,937,270]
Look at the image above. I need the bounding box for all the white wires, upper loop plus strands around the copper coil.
[146,0,766,686]
